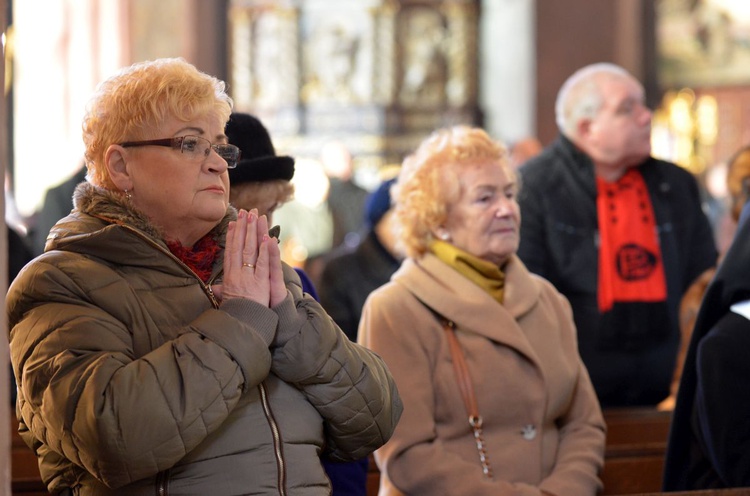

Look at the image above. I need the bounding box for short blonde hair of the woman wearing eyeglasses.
[82,58,233,190]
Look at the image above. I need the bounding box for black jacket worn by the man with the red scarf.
[518,136,717,407]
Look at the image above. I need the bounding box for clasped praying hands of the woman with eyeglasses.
[213,209,286,308]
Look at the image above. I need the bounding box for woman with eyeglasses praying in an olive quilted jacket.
[7,59,401,496]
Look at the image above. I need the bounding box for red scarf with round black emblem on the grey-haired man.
[596,168,667,313]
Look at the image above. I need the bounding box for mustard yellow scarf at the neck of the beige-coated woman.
[430,240,505,303]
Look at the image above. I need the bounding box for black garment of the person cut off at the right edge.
[664,222,750,491]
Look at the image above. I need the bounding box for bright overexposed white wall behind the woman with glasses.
[13,0,126,217]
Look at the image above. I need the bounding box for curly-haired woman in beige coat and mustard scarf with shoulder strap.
[359,126,605,496]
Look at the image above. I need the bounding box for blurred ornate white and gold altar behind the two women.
[228,0,481,164]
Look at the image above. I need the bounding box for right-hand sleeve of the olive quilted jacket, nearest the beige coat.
[271,266,403,461]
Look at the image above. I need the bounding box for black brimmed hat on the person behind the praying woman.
[224,112,294,184]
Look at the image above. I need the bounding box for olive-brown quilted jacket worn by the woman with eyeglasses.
[6,183,401,496]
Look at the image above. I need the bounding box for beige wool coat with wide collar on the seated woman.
[359,254,605,496]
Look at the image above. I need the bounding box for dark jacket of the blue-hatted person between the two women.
[318,231,401,341]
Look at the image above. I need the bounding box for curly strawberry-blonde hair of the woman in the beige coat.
[391,125,516,258]
